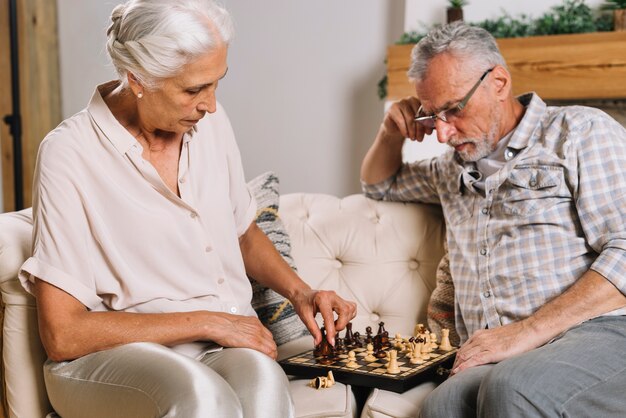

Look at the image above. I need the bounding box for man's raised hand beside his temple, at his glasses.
[382,97,433,142]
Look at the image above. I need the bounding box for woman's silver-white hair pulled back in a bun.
[106,0,234,88]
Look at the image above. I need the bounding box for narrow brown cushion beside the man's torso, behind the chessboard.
[427,242,459,347]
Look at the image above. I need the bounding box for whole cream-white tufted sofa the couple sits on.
[0,194,445,418]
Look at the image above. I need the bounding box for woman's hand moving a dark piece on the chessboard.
[291,289,356,345]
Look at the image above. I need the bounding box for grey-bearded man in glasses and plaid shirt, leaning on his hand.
[361,23,626,418]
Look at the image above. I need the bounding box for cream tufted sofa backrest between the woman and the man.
[279,193,445,335]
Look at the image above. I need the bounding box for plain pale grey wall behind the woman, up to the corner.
[58,0,404,195]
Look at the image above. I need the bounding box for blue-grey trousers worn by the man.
[421,316,626,418]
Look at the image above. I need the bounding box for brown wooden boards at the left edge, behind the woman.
[0,0,61,211]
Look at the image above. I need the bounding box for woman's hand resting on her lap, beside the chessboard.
[209,312,278,359]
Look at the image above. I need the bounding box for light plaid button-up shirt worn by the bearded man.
[363,94,626,342]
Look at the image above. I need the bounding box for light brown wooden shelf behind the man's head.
[387,31,626,100]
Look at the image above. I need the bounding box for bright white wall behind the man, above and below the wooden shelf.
[403,0,604,161]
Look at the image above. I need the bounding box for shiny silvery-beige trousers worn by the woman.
[44,343,294,418]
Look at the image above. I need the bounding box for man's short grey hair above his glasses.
[407,22,506,81]
